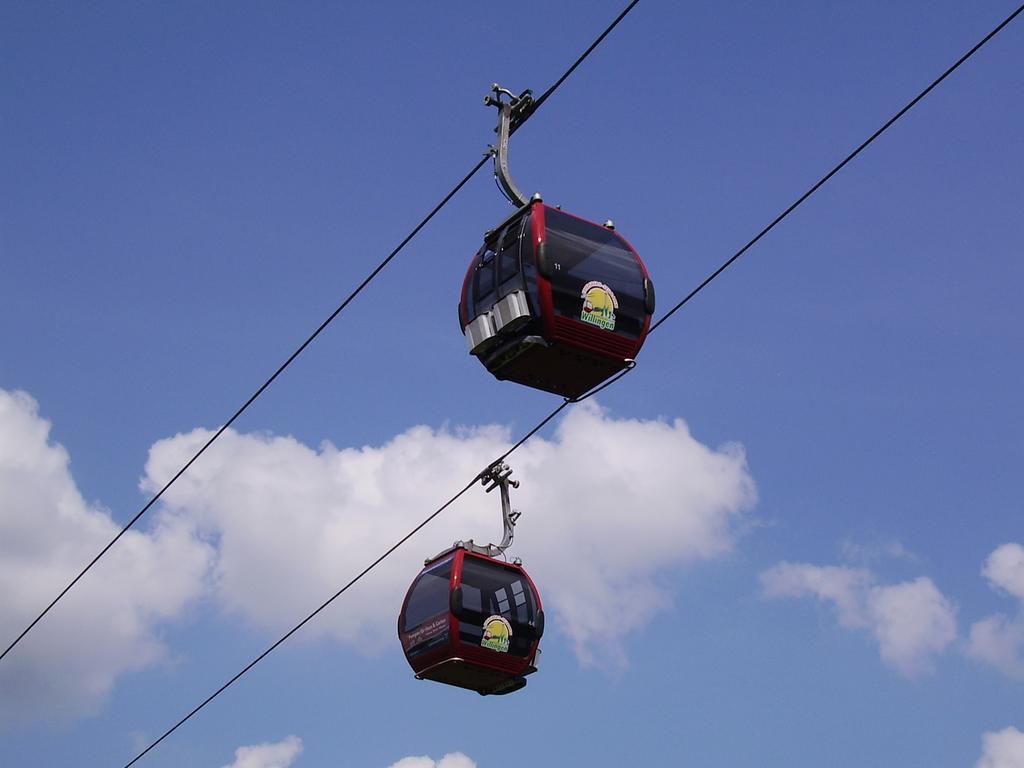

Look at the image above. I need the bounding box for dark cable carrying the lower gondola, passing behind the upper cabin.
[114,0,1024,768]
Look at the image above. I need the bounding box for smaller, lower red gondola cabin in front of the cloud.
[398,547,544,695]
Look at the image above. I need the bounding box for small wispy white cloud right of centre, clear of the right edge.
[761,562,956,677]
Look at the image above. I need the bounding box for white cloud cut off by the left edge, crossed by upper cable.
[0,390,212,724]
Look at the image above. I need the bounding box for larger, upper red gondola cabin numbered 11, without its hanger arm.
[459,197,654,397]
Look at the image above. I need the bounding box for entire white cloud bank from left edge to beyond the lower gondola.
[0,390,756,729]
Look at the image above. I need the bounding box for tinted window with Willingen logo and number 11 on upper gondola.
[544,208,646,338]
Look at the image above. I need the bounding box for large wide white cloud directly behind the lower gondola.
[143,403,755,665]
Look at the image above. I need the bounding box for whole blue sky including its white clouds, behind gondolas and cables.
[0,0,1024,768]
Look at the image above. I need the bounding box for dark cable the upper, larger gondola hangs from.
[0,0,639,662]
